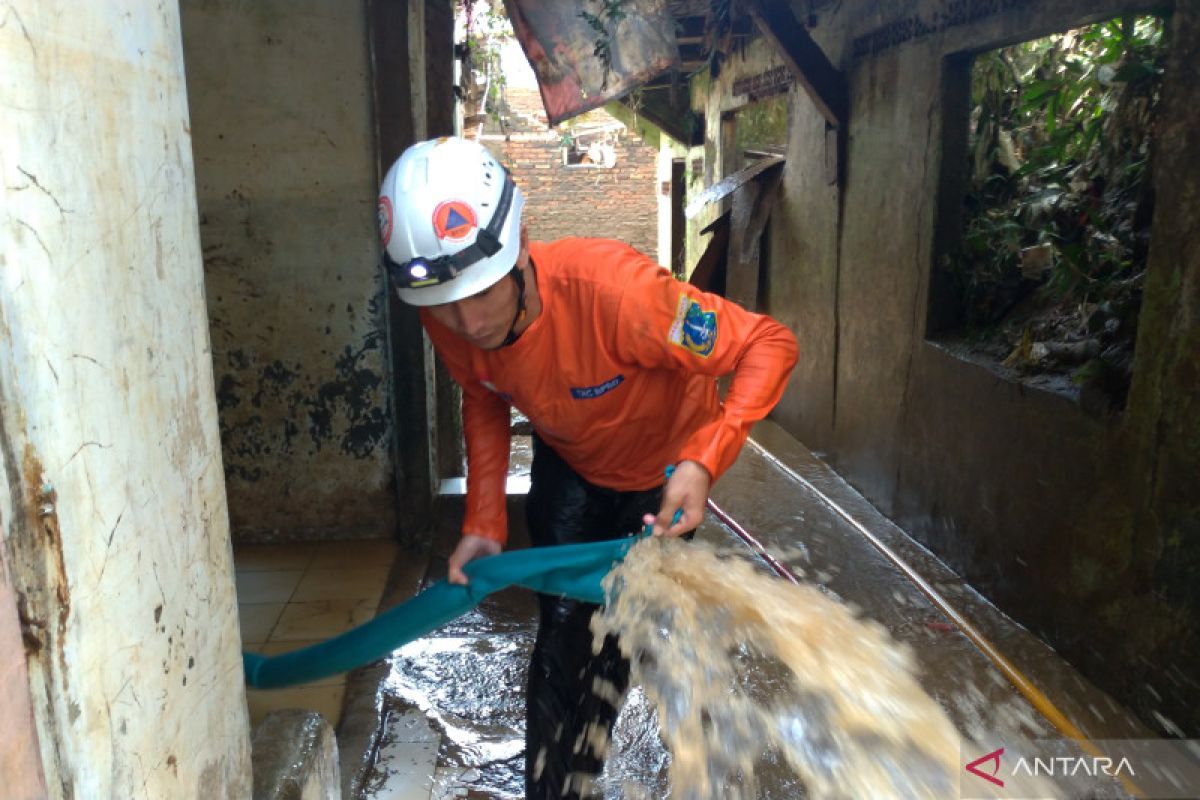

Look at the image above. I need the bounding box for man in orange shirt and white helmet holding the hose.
[379,138,797,800]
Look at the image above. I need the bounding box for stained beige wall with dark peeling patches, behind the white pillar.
[181,0,396,539]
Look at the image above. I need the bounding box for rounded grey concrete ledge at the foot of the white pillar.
[251,709,342,800]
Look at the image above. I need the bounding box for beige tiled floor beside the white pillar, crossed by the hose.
[234,540,398,727]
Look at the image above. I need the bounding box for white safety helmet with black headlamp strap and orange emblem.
[378,137,524,306]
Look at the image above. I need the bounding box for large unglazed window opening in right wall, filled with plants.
[929,16,1168,411]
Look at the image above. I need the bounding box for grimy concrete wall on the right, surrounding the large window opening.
[694,0,1200,735]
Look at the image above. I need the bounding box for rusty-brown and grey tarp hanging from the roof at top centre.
[504,0,679,125]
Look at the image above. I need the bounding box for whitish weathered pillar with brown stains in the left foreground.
[0,0,250,798]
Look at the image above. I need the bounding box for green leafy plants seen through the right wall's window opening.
[946,17,1166,326]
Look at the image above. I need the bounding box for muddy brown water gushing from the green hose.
[588,539,960,800]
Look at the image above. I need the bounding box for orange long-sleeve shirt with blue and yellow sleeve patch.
[421,239,797,542]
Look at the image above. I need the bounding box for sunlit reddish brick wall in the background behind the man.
[482,132,658,258]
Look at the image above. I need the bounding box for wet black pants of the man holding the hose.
[526,437,662,800]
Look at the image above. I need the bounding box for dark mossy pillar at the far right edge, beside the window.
[1112,2,1200,736]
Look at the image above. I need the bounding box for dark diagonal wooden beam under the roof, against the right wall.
[746,0,850,127]
